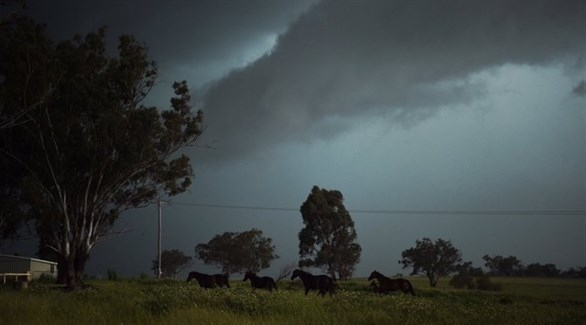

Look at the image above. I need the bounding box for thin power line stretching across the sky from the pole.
[170,202,586,216]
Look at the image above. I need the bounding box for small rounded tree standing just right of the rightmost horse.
[399,238,462,287]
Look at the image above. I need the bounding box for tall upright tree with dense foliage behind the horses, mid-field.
[299,186,362,279]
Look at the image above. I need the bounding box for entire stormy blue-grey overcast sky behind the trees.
[3,0,586,276]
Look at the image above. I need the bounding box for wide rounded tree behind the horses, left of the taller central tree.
[195,228,279,274]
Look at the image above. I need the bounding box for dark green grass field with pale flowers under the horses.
[0,278,586,325]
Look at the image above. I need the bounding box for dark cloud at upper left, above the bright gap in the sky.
[21,0,314,85]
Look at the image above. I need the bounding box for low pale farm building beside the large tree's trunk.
[0,254,57,283]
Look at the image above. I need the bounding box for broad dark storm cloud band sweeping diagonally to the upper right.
[203,1,586,162]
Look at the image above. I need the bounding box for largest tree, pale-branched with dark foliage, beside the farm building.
[0,17,203,286]
